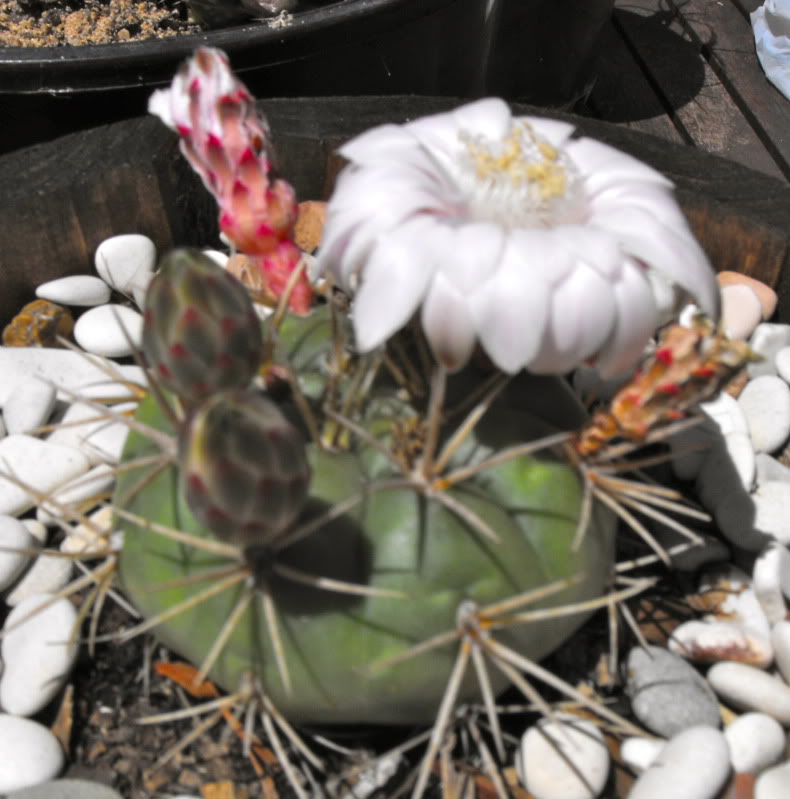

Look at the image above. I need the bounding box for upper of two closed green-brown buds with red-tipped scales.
[143,249,263,404]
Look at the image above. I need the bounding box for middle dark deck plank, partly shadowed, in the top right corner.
[614,0,783,177]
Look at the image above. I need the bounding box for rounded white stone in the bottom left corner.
[0,713,65,794]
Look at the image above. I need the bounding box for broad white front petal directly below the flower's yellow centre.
[469,233,549,374]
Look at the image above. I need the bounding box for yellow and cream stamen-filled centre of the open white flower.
[460,120,586,228]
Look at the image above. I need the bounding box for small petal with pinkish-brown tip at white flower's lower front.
[422,272,475,372]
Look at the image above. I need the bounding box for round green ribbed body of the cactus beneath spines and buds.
[115,304,615,724]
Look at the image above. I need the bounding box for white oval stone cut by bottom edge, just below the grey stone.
[628,727,730,799]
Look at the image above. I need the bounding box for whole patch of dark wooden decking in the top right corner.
[582,0,790,181]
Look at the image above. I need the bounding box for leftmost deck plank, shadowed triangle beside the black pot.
[577,22,686,144]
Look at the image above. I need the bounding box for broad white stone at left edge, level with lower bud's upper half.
[0,436,90,516]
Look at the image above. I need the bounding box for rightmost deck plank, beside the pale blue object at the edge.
[668,0,790,180]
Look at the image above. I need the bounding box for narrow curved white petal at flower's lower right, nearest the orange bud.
[595,262,658,378]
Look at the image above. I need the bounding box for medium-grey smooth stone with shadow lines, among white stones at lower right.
[626,646,719,738]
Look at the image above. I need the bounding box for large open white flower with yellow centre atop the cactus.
[318,98,719,374]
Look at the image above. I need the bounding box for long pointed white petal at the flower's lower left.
[352,217,436,352]
